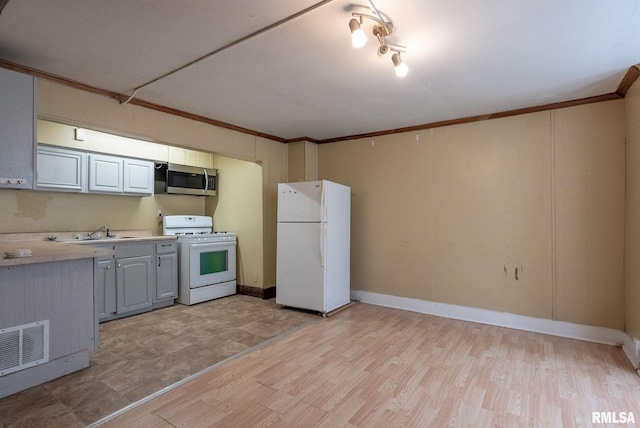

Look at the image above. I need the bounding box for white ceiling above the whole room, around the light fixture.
[0,0,640,141]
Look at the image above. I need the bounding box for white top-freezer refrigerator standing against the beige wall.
[276,180,351,314]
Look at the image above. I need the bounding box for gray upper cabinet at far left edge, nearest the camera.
[0,68,36,189]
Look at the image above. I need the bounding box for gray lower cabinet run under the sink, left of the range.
[94,241,178,321]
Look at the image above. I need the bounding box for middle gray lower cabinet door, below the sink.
[116,255,154,314]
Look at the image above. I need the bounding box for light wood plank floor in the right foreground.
[95,303,640,428]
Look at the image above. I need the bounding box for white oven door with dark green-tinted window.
[189,242,236,288]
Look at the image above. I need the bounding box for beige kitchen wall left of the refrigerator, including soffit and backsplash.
[0,80,287,287]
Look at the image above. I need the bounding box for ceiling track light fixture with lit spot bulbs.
[349,1,409,77]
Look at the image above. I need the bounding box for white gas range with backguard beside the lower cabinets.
[163,215,236,305]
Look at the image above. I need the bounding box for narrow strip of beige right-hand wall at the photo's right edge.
[624,81,640,337]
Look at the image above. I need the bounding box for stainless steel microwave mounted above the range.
[155,163,218,196]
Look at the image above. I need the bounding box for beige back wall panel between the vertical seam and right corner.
[551,101,625,329]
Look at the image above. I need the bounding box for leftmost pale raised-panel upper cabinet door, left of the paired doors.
[36,145,87,192]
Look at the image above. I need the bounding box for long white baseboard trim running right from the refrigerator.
[351,290,640,369]
